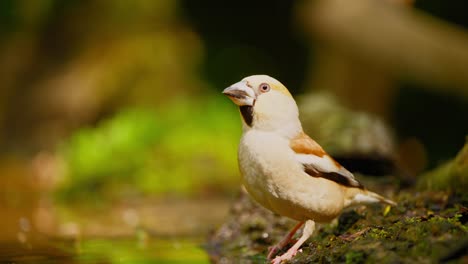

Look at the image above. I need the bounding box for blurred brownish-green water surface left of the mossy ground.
[0,158,228,263]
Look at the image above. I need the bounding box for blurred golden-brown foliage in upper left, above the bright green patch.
[0,0,203,154]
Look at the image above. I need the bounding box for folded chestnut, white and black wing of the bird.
[290,133,364,188]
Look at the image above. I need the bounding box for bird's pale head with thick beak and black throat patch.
[223,75,302,136]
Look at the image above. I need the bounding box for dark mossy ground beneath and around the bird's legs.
[207,190,468,263]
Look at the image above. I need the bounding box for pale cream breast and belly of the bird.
[239,130,343,222]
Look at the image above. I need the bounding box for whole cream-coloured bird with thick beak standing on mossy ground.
[223,75,396,264]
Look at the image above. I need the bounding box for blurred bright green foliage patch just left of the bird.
[58,96,240,199]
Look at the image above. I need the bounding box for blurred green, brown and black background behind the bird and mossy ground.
[0,0,468,263]
